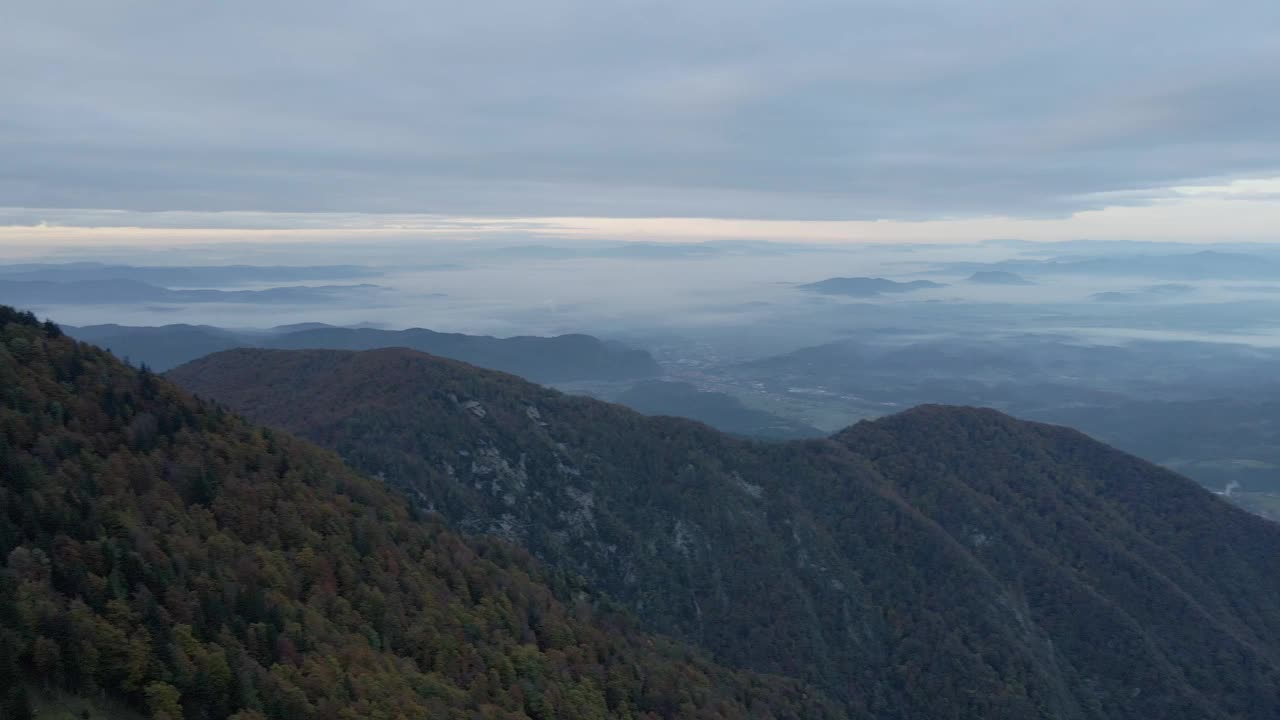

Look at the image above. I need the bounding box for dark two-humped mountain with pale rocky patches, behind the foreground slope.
[170,350,1280,720]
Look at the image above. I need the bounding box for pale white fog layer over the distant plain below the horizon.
[15,238,1280,352]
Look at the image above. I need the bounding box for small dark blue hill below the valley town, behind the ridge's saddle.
[614,380,823,439]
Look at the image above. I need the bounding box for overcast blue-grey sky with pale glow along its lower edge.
[0,0,1280,251]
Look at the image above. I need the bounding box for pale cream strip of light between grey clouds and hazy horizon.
[0,178,1280,256]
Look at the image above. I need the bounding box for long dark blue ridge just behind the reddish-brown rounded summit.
[63,323,662,382]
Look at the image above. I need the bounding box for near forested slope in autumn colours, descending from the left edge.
[0,307,847,720]
